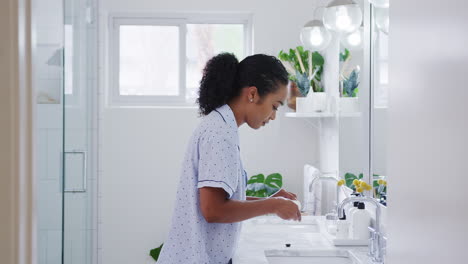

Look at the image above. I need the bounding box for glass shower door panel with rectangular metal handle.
[63,0,97,264]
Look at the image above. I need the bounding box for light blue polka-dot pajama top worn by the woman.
[157,105,247,264]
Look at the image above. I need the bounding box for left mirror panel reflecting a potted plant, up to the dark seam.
[339,1,371,196]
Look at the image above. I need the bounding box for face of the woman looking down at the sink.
[246,85,288,129]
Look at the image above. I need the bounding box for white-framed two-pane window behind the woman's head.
[109,14,251,105]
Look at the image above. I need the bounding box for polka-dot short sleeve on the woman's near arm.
[197,134,240,198]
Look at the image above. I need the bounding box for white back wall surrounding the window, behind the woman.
[99,0,326,263]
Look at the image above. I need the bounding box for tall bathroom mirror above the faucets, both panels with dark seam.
[339,0,389,205]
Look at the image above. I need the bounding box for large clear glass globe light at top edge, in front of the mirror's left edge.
[323,0,362,33]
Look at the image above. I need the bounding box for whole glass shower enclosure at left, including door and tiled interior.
[33,0,98,264]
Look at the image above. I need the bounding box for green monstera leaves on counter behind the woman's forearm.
[245,173,283,197]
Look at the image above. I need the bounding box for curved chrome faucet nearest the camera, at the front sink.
[337,196,387,263]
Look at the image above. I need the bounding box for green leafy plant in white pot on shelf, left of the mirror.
[278,46,326,112]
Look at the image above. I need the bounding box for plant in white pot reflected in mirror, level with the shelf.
[340,49,360,113]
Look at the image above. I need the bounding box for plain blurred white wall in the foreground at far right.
[388,0,468,264]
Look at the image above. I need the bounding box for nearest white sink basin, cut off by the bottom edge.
[265,250,357,264]
